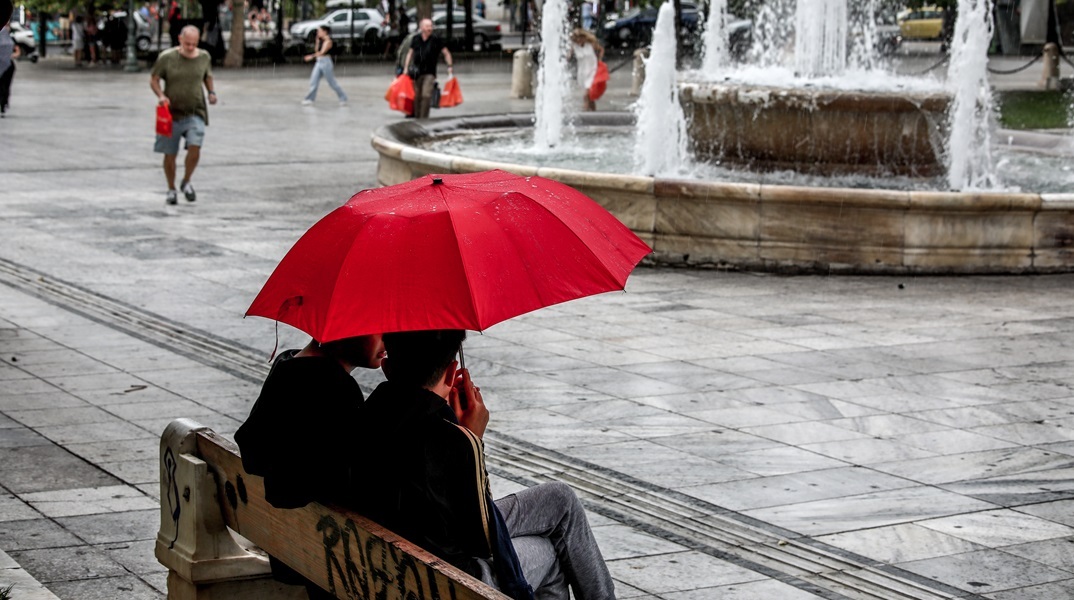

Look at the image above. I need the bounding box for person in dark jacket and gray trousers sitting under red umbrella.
[355,330,615,600]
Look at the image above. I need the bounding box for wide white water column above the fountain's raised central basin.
[795,0,846,77]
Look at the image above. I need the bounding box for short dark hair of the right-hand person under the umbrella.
[383,330,466,387]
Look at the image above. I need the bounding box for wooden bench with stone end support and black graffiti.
[156,419,509,600]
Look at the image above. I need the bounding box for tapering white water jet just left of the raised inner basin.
[634,1,687,175]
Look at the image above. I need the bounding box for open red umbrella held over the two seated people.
[246,171,652,342]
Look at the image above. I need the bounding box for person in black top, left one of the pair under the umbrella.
[235,335,384,600]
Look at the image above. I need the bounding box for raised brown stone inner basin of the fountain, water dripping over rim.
[679,81,950,177]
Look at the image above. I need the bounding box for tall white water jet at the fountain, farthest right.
[946,0,997,191]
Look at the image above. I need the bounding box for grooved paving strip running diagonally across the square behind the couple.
[0,258,986,600]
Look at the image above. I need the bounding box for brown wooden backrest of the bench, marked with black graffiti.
[158,420,509,600]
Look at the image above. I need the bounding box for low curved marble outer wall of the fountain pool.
[373,113,1074,274]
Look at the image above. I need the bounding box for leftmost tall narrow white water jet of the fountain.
[534,0,570,149]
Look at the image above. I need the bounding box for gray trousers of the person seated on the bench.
[481,483,615,600]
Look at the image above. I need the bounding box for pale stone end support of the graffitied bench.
[156,419,306,600]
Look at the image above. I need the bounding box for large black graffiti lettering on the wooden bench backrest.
[317,514,456,600]
